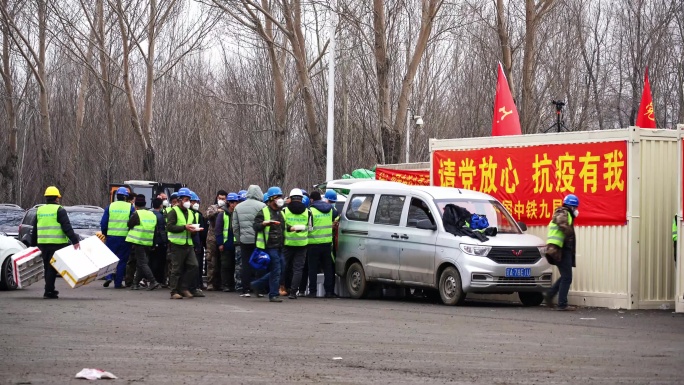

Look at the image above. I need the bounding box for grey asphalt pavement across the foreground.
[0,278,684,385]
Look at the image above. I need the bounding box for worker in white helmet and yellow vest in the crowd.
[280,188,311,299]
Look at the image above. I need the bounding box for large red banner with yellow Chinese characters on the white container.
[432,141,627,226]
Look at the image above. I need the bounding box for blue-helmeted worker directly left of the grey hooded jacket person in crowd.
[219,193,239,293]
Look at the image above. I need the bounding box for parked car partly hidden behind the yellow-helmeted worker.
[19,204,104,246]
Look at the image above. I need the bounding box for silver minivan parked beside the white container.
[328,181,552,306]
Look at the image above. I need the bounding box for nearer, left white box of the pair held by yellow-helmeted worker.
[50,241,99,288]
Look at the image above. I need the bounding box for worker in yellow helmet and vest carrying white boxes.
[31,186,80,299]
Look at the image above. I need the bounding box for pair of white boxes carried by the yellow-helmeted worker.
[50,236,119,288]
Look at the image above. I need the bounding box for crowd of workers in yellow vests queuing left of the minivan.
[95,185,337,302]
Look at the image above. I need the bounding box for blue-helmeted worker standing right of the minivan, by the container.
[544,194,579,310]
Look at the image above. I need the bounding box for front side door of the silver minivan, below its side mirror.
[398,197,437,285]
